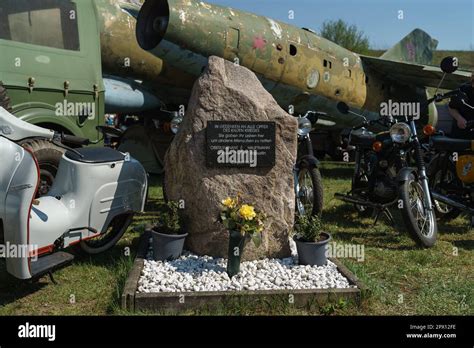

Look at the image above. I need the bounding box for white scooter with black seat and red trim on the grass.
[0,108,148,281]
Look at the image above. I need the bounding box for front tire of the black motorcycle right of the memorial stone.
[398,175,438,248]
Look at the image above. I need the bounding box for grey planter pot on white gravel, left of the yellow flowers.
[151,230,188,261]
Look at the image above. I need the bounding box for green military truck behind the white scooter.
[0,0,105,194]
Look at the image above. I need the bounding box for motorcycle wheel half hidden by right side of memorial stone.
[296,168,323,216]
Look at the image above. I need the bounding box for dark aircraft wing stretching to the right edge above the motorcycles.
[361,56,471,90]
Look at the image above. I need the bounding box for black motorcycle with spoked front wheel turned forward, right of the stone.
[336,96,440,247]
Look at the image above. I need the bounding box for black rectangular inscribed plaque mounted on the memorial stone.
[206,121,275,168]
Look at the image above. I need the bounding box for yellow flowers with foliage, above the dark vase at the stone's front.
[221,196,266,247]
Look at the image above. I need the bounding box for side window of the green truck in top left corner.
[0,0,80,51]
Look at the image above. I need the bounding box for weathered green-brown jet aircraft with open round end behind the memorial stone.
[133,0,469,135]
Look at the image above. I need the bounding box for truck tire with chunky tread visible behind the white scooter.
[20,139,65,197]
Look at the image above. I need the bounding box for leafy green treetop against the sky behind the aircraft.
[321,19,370,54]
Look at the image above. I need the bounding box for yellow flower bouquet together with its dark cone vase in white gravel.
[220,196,266,277]
